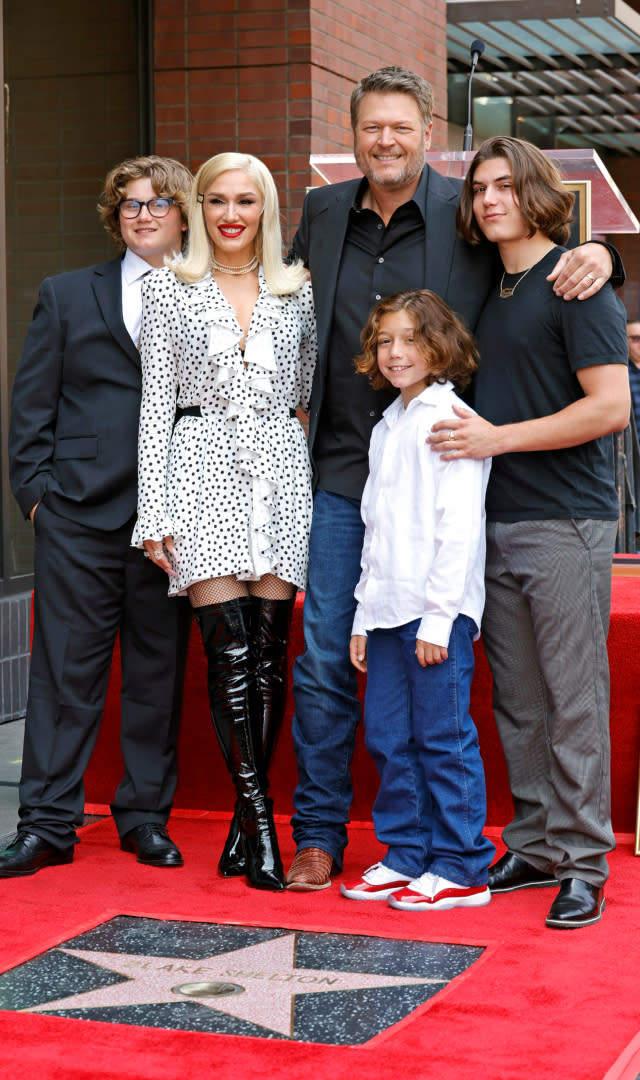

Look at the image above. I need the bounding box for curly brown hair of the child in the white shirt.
[355,288,478,390]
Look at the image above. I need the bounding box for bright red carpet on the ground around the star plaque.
[0,815,640,1080]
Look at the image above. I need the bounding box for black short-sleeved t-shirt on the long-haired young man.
[473,247,628,522]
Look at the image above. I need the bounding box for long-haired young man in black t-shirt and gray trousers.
[431,138,629,929]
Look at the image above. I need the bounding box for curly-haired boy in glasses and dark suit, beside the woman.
[0,157,191,877]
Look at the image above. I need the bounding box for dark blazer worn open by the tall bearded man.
[292,165,498,460]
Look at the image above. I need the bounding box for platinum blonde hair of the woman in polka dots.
[168,152,307,296]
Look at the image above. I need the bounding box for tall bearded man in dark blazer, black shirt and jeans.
[287,67,611,890]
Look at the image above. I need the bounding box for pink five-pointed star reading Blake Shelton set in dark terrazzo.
[24,933,448,1037]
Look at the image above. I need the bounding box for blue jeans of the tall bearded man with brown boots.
[291,491,365,866]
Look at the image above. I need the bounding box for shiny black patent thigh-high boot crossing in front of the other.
[194,596,285,890]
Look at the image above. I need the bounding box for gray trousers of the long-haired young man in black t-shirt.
[482,519,616,886]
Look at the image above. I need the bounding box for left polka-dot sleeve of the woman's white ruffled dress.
[132,271,178,548]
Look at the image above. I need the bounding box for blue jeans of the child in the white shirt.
[365,615,495,888]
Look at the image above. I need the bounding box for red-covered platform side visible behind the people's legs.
[86,567,640,833]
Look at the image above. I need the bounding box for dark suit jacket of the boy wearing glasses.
[9,258,141,529]
